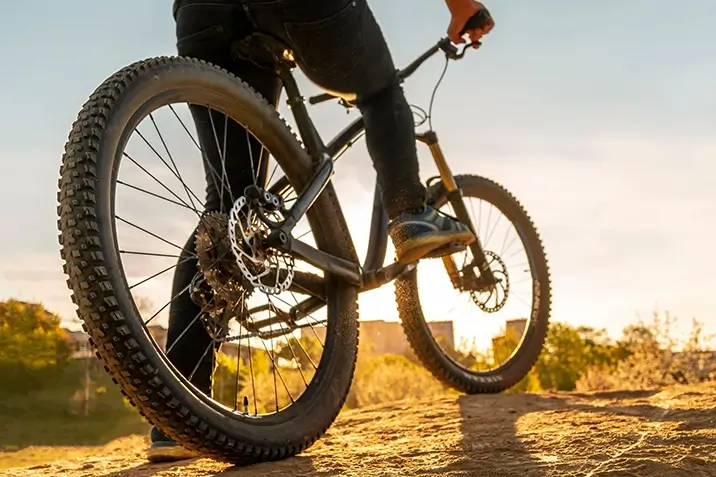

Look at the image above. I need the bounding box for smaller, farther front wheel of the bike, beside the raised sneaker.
[395,175,551,394]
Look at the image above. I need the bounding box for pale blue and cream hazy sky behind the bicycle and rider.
[0,0,716,342]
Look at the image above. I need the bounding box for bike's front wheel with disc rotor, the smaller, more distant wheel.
[395,175,551,394]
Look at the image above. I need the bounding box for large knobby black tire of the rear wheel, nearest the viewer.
[58,57,358,464]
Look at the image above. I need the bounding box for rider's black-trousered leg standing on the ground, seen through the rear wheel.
[149,0,280,461]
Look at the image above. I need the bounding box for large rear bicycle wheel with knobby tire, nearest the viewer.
[58,54,357,463]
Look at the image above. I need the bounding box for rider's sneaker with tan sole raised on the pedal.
[388,206,475,263]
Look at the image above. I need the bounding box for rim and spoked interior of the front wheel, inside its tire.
[416,184,539,376]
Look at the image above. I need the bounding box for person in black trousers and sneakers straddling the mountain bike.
[149,0,494,461]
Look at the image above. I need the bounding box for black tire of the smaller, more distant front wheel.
[395,175,551,394]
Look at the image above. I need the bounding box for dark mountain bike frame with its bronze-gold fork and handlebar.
[252,39,495,292]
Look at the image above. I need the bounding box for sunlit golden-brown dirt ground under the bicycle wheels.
[0,385,716,477]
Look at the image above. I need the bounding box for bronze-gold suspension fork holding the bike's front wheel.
[416,131,496,286]
